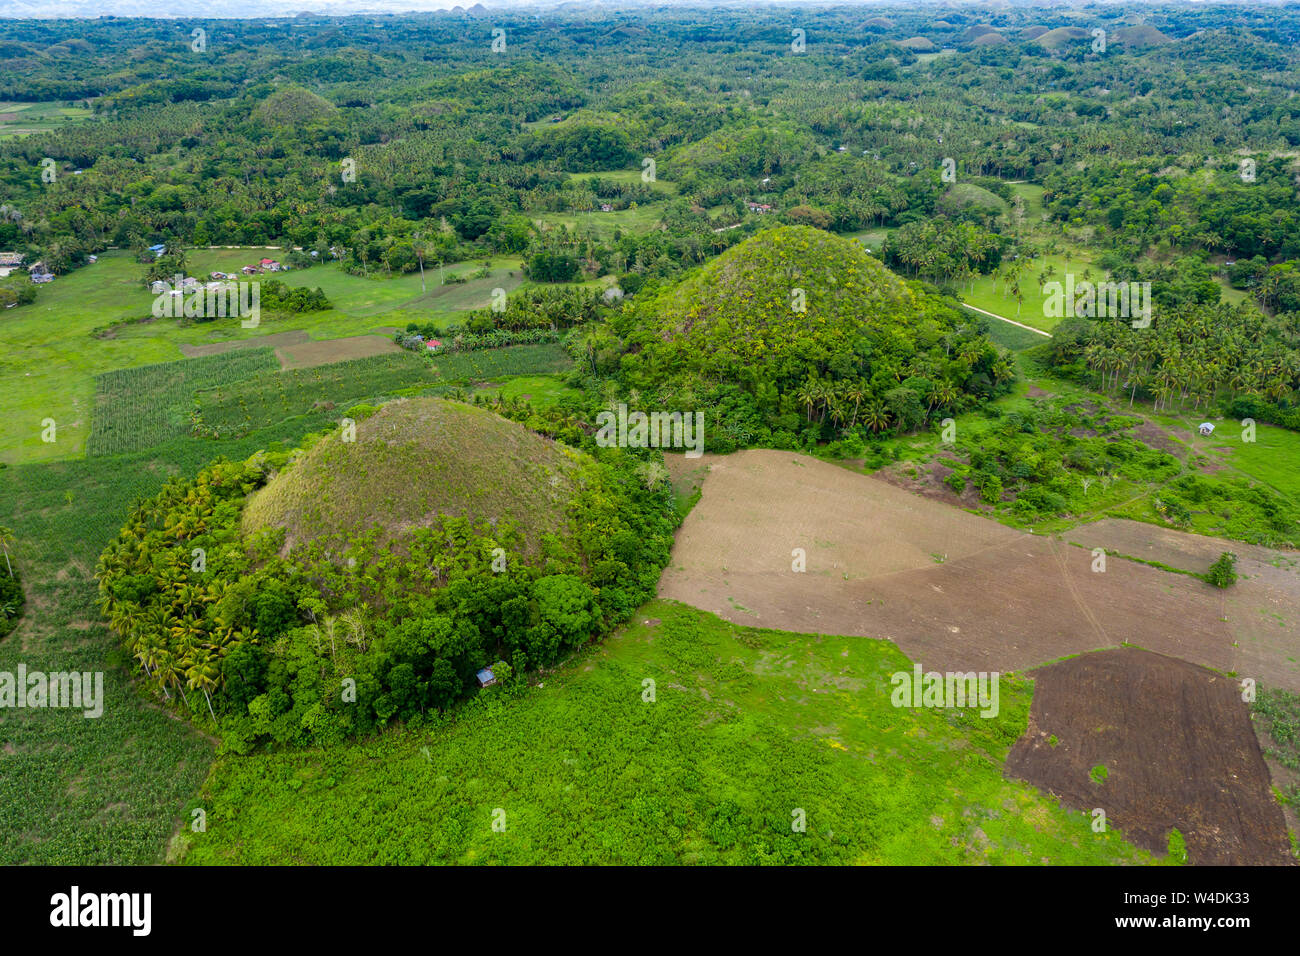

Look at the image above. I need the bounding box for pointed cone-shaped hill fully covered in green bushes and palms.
[608,226,1013,451]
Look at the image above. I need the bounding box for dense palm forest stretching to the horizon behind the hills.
[0,2,1300,299]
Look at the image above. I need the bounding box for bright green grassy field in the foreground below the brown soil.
[172,601,1149,864]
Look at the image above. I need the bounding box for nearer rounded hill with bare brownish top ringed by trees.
[98,399,676,752]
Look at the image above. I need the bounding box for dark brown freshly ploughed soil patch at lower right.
[1006,648,1295,866]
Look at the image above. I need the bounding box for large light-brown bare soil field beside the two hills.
[659,450,1300,691]
